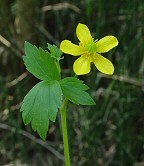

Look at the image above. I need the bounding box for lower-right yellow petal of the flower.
[94,54,114,74]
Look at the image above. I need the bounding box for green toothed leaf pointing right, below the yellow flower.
[60,77,95,105]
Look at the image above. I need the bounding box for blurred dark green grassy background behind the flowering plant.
[0,0,144,166]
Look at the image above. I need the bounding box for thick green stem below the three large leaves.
[60,99,70,166]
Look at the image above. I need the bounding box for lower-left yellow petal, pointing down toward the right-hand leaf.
[73,55,91,75]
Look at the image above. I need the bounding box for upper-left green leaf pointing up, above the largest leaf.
[23,42,60,80]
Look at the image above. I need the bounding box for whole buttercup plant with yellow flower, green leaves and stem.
[20,23,118,166]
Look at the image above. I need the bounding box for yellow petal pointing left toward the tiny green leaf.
[60,40,85,56]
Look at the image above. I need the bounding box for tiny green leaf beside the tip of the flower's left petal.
[47,43,63,61]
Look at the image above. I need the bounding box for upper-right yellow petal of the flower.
[96,36,118,53]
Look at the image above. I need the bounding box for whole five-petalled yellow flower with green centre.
[60,23,118,75]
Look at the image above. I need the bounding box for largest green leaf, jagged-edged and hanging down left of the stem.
[20,80,62,139]
